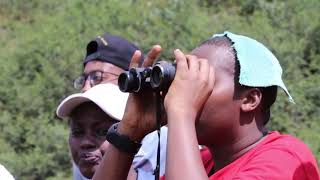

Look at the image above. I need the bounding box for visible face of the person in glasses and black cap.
[82,60,124,92]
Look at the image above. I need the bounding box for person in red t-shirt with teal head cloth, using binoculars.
[94,32,319,180]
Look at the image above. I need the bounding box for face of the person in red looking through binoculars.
[192,45,240,145]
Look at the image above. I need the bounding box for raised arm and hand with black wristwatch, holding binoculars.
[93,45,161,180]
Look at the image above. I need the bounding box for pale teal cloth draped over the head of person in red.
[212,31,294,103]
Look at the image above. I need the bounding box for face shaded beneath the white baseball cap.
[69,103,116,178]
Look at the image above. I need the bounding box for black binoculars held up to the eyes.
[118,61,176,92]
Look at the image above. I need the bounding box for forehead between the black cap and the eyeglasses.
[84,60,124,74]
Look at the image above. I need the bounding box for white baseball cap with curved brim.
[56,83,129,121]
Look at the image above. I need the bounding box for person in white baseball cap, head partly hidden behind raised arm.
[57,84,128,179]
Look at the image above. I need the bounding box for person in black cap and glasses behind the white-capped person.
[67,33,167,180]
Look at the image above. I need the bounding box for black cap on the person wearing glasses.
[83,33,143,70]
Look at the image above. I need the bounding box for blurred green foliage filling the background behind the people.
[0,0,320,180]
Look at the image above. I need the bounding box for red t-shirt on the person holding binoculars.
[161,131,320,180]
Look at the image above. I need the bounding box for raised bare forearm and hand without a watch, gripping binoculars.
[165,50,214,180]
